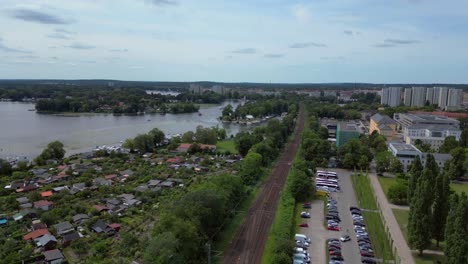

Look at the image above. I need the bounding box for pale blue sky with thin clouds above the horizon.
[0,0,468,83]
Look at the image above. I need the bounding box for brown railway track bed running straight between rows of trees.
[221,107,305,264]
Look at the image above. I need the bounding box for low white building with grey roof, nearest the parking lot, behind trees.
[388,143,452,171]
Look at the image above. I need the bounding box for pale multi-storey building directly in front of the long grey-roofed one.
[403,125,461,150]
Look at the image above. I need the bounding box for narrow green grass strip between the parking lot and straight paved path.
[352,175,393,260]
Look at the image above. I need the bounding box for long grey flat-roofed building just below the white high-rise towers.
[393,113,460,130]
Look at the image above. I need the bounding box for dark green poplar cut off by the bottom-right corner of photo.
[445,193,468,264]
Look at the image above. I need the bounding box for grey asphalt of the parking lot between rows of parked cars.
[298,169,361,264]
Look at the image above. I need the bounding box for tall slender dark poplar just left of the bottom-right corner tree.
[431,170,450,247]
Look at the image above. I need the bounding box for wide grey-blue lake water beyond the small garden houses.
[0,102,249,158]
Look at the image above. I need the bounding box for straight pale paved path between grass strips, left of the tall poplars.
[369,172,415,264]
